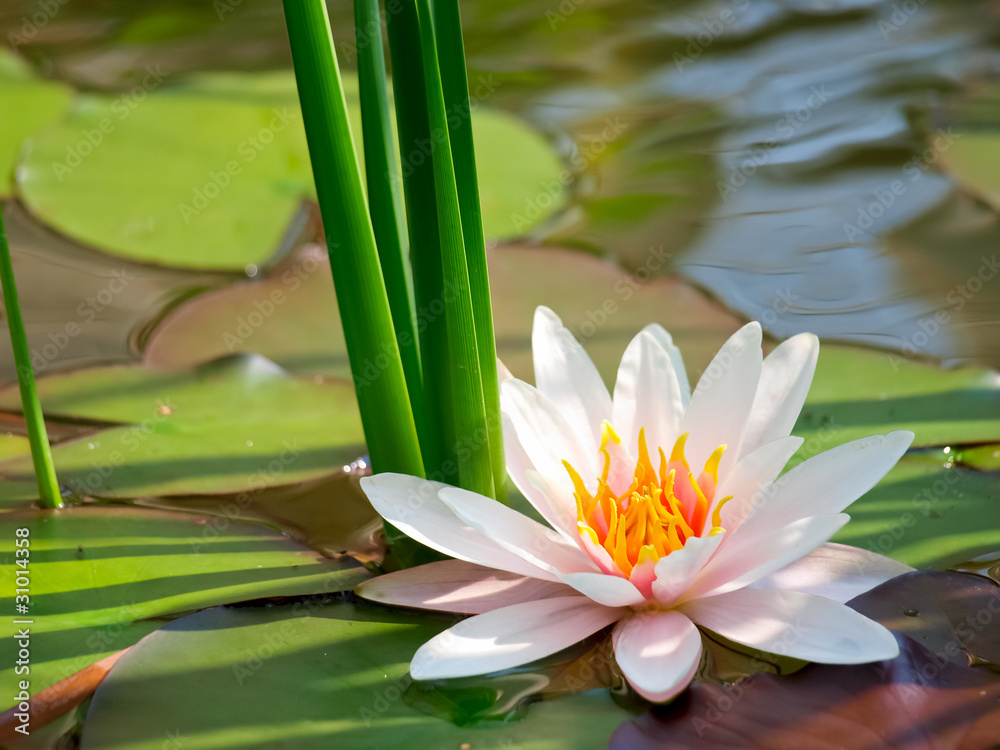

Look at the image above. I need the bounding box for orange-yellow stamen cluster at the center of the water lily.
[563,422,732,577]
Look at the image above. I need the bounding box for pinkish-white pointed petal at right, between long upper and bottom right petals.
[747,542,913,603]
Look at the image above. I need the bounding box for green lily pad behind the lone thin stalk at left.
[0,355,364,507]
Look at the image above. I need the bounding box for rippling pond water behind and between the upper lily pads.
[0,0,1000,376]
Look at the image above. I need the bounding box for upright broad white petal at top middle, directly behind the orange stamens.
[611,331,684,456]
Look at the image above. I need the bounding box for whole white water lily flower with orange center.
[359,308,913,701]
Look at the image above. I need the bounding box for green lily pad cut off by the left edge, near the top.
[0,49,73,198]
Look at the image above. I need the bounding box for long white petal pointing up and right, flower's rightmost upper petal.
[736,430,913,537]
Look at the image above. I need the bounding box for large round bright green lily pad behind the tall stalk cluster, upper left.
[18,67,562,270]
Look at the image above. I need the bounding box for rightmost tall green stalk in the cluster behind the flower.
[433,0,507,499]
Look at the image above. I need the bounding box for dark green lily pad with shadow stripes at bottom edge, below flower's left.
[82,604,630,750]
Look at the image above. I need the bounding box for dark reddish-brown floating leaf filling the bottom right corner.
[610,634,1000,750]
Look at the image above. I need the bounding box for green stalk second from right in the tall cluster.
[417,0,496,506]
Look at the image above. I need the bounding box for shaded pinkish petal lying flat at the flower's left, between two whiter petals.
[354,560,573,615]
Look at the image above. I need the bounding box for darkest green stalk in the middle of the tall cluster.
[386,0,450,484]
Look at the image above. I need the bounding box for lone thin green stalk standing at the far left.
[0,207,63,508]
